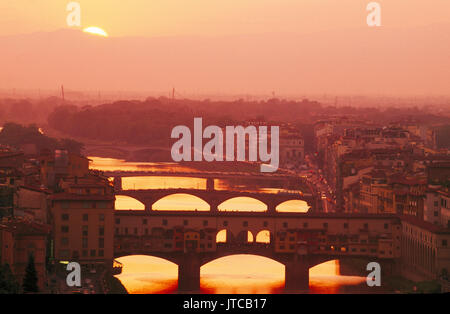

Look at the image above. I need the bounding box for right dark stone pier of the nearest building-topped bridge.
[285,256,309,293]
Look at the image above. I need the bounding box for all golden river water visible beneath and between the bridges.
[89,157,370,294]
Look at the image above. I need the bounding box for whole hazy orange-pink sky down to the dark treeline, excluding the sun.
[0,0,450,97]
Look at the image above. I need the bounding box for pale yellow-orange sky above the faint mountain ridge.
[0,0,450,36]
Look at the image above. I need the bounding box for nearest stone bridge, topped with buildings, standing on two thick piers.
[114,211,401,291]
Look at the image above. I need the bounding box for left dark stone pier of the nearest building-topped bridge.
[178,252,201,293]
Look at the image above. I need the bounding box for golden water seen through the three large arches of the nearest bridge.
[116,255,365,294]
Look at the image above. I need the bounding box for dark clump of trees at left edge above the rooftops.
[0,122,83,154]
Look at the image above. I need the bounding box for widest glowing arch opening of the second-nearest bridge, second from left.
[152,193,211,211]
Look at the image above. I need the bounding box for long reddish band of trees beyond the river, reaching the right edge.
[44,97,449,151]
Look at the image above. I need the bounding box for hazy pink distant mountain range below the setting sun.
[0,25,450,95]
